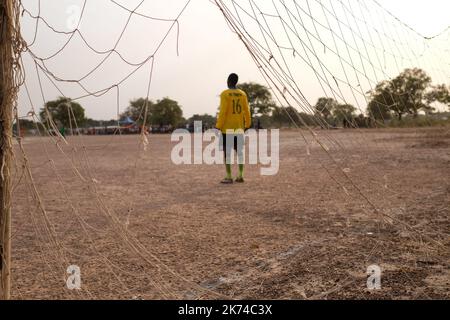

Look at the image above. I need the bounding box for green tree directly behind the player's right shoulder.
[238,82,275,117]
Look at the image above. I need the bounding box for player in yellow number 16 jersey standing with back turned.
[216,73,251,184]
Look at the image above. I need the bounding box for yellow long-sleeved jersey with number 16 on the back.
[216,89,252,133]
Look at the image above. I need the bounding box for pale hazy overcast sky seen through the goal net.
[19,0,450,119]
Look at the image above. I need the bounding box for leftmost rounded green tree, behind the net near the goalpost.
[39,97,86,127]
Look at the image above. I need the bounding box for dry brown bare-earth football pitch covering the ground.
[12,128,450,299]
